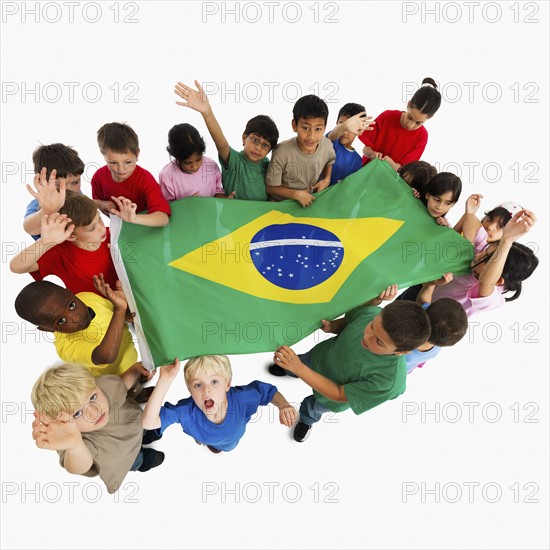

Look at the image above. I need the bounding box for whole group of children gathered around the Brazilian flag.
[10,78,538,492]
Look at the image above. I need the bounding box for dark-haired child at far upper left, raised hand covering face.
[23,143,84,240]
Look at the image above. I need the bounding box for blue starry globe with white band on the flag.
[250,223,344,290]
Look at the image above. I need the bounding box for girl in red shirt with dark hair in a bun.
[359,78,441,171]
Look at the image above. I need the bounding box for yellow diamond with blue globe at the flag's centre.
[169,210,404,304]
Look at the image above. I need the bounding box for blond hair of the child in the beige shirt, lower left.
[31,363,96,419]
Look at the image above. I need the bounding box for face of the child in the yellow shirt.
[38,287,95,334]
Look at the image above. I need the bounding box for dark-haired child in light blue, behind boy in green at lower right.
[405,298,468,374]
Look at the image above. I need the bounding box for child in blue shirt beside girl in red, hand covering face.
[327,103,373,185]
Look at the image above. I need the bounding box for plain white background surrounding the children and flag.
[1,2,549,548]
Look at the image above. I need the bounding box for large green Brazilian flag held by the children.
[111,161,473,368]
